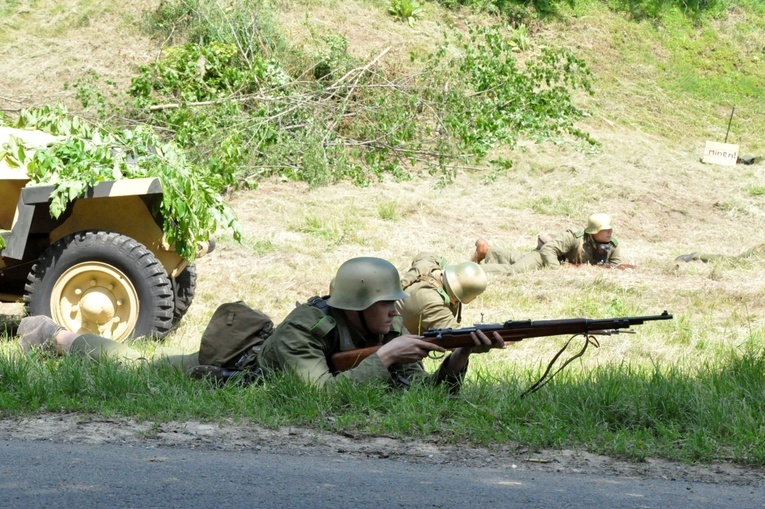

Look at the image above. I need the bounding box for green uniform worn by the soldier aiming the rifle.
[69,304,467,388]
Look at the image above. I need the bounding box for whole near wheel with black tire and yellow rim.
[24,231,173,341]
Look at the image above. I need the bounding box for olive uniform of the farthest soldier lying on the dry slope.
[481,230,622,274]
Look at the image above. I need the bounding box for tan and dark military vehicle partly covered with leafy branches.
[0,126,214,341]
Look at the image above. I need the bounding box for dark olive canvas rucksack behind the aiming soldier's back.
[199,300,274,371]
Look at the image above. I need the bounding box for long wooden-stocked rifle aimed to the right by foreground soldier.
[332,311,672,371]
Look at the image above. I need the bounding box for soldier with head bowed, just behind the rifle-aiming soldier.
[396,253,488,334]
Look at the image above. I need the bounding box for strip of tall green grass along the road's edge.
[0,344,765,466]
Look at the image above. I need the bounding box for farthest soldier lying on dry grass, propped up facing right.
[472,213,632,274]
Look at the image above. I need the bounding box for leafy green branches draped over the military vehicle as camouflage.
[0,105,241,261]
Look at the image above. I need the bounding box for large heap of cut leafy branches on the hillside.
[68,0,595,192]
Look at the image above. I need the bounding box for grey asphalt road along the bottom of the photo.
[0,440,765,509]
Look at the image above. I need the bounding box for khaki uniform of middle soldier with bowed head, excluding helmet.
[396,253,462,335]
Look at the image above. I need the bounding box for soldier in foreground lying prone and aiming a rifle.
[18,257,504,390]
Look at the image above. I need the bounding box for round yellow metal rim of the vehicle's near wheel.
[50,262,140,341]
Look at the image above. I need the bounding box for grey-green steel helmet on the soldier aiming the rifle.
[327,257,409,311]
